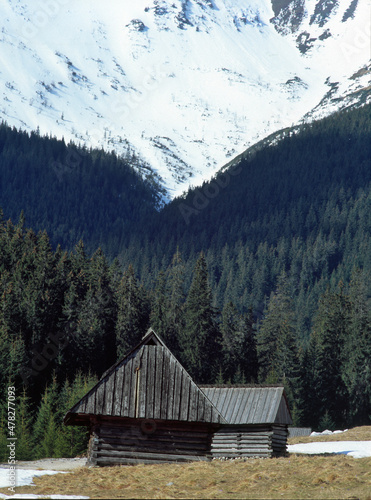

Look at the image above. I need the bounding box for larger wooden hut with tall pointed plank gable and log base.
[64,330,224,465]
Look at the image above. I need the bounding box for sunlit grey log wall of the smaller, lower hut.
[211,425,287,458]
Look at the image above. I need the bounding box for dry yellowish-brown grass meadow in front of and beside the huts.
[0,426,371,500]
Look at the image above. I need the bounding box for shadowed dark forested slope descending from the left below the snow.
[0,123,159,256]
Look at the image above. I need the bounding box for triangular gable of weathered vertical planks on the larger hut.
[64,330,225,425]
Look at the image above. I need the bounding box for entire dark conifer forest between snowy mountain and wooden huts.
[0,105,371,459]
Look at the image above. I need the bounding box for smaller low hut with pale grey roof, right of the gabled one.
[201,386,292,458]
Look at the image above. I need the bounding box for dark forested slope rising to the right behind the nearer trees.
[121,106,371,338]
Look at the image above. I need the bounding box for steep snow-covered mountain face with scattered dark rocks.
[0,0,371,198]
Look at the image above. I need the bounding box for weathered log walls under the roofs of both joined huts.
[88,418,288,466]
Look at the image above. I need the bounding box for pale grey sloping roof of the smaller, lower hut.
[201,386,292,425]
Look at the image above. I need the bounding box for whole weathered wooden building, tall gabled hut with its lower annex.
[64,330,292,465]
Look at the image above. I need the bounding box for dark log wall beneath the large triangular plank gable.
[88,420,215,466]
